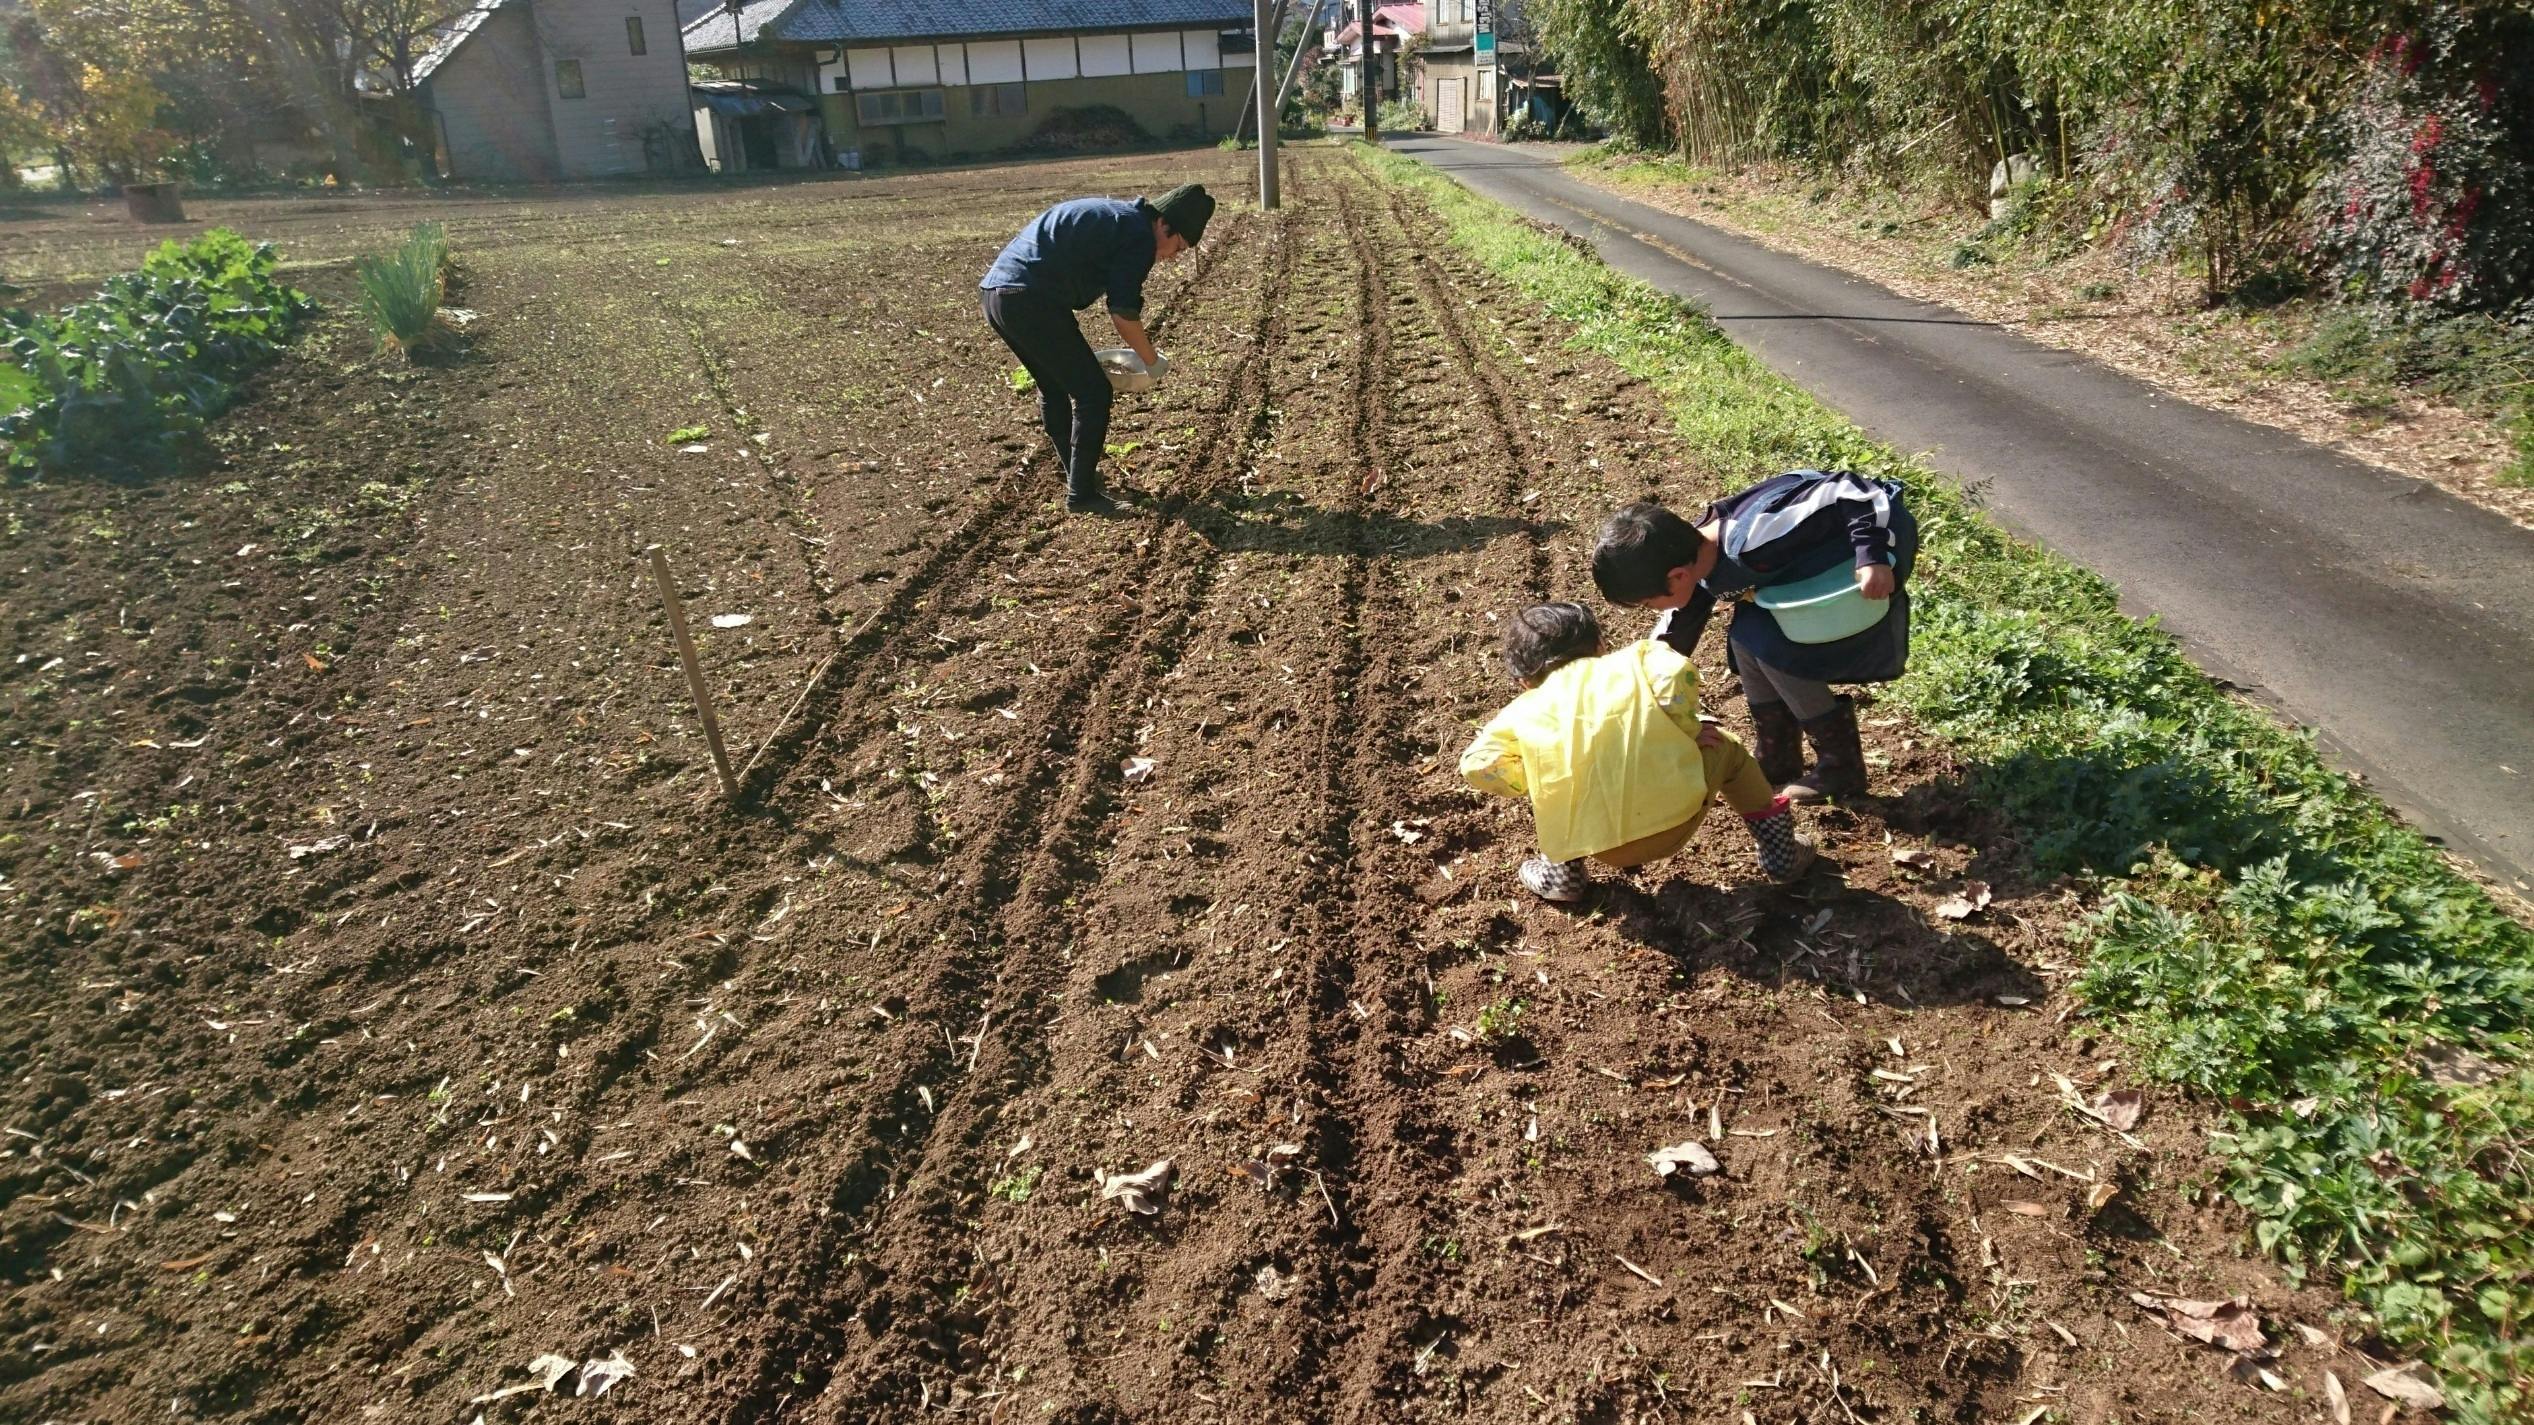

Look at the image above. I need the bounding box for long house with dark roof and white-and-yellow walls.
[684,0,1257,162]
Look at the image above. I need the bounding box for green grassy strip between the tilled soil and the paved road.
[1351,145,2534,1422]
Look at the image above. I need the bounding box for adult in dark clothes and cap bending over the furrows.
[978,183,1214,515]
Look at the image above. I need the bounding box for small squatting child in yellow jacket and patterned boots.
[1460,603,1814,903]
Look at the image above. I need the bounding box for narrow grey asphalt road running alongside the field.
[1389,137,2534,890]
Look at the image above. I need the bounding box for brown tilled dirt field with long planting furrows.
[0,150,2364,1425]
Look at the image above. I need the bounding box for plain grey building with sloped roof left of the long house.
[416,0,697,183]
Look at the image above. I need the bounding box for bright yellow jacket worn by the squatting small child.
[1460,639,1708,862]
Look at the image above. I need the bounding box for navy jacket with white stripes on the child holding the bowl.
[1655,469,1918,682]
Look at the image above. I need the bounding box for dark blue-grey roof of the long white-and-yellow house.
[687,0,1249,53]
